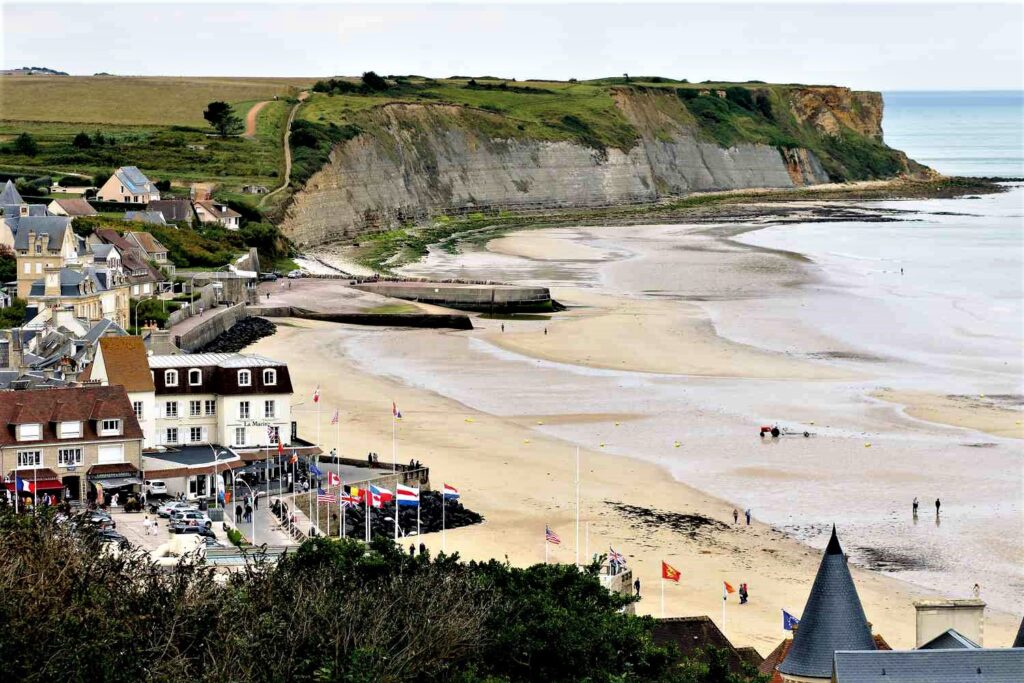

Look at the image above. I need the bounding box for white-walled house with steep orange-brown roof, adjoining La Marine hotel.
[80,336,157,449]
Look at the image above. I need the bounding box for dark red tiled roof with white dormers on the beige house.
[0,386,142,445]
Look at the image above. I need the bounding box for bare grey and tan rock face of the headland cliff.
[282,88,897,246]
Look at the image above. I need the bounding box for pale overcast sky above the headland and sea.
[0,0,1024,90]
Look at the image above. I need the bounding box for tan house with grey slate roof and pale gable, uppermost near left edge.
[14,216,78,299]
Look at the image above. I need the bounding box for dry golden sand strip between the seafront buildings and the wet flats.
[249,321,1017,654]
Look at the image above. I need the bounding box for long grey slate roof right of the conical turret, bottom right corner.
[831,651,1024,683]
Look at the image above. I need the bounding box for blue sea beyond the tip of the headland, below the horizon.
[882,90,1024,178]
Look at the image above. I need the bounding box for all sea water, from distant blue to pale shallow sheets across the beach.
[343,92,1024,610]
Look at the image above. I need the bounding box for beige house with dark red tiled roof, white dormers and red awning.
[0,386,142,502]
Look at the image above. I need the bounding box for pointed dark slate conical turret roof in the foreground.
[778,525,876,679]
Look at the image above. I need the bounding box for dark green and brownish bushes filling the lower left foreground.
[0,510,760,683]
